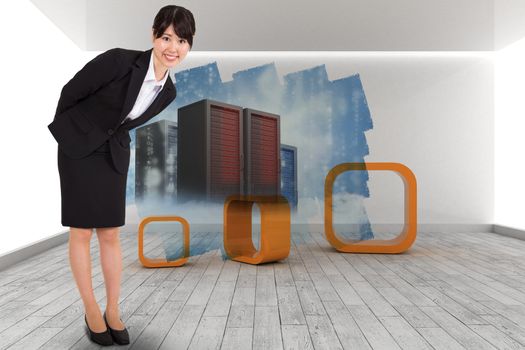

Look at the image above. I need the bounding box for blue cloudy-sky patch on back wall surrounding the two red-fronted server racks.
[127,63,373,255]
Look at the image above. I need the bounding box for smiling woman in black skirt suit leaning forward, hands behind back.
[48,5,195,345]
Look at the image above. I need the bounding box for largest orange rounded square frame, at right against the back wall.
[324,162,417,254]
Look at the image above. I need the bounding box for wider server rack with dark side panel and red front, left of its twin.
[177,99,244,201]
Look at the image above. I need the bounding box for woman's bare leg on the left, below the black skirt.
[69,227,106,333]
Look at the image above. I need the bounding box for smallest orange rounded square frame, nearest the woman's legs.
[138,216,190,267]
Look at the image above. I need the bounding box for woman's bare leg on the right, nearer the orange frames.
[97,227,124,330]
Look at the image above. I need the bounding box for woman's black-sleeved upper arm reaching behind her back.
[55,48,120,118]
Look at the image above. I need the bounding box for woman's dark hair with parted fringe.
[153,5,195,47]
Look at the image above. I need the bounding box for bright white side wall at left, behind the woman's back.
[0,0,97,254]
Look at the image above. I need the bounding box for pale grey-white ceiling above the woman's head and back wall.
[32,0,525,51]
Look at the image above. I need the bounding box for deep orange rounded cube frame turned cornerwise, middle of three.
[224,195,290,265]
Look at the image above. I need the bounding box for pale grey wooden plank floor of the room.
[0,233,525,350]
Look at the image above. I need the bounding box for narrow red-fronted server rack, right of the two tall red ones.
[243,108,281,195]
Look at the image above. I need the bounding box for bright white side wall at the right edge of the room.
[494,0,525,230]
